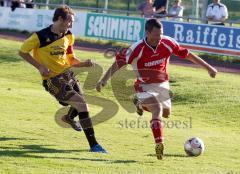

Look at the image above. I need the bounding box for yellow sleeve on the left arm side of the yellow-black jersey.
[20,33,40,53]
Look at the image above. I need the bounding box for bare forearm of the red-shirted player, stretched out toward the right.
[187,52,217,78]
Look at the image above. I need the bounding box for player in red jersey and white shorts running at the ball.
[96,19,217,159]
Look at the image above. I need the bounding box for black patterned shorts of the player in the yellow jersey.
[42,70,82,105]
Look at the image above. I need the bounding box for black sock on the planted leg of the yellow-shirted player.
[78,112,98,147]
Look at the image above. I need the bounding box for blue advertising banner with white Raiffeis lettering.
[162,21,240,57]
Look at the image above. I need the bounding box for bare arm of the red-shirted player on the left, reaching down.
[96,61,120,92]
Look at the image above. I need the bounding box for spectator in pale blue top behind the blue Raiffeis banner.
[167,0,183,21]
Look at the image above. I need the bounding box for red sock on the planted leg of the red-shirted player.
[150,119,164,144]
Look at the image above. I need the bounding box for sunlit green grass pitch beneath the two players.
[0,39,240,174]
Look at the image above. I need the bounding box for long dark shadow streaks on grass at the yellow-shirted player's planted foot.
[0,145,137,164]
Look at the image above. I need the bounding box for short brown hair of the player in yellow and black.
[53,5,75,22]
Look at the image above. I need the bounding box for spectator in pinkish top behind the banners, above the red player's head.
[137,0,155,18]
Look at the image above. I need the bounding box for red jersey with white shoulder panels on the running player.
[116,36,189,91]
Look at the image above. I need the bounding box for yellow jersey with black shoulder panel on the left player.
[20,26,74,79]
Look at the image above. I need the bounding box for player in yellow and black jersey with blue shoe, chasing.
[19,6,106,153]
